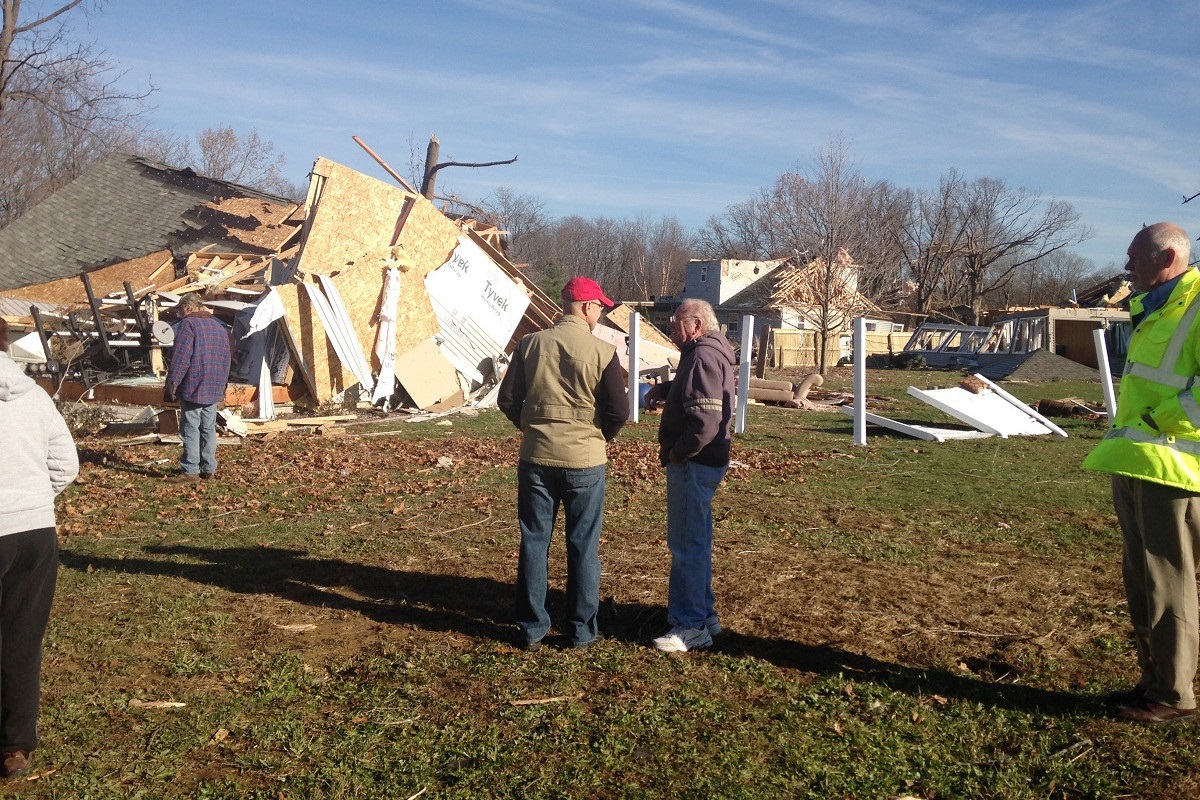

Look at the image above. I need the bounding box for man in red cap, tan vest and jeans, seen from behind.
[498,276,628,650]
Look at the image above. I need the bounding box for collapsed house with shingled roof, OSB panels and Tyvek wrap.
[0,156,592,416]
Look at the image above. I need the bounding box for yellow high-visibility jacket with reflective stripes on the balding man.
[1084,269,1200,493]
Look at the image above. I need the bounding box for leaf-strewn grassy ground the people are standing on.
[2,372,1200,799]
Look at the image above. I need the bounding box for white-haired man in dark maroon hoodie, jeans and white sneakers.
[648,300,737,652]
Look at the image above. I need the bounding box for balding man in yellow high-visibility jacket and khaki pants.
[1084,222,1200,724]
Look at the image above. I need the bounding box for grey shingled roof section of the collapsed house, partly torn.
[0,154,296,290]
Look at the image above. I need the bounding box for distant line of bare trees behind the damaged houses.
[465,138,1098,321]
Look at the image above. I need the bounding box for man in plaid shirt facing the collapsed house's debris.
[163,294,233,483]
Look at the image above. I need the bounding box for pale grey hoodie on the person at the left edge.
[0,351,79,536]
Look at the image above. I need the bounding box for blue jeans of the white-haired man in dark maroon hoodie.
[666,461,727,627]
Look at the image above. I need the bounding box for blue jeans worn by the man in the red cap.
[516,462,607,645]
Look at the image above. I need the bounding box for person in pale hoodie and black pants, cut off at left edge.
[0,319,79,777]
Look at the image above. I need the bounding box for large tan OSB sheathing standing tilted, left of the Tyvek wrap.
[300,158,461,367]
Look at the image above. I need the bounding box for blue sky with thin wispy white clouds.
[77,0,1200,266]
